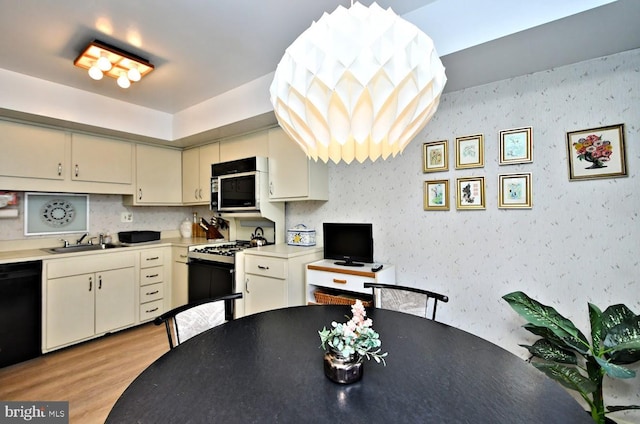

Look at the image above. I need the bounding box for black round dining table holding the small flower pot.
[107,305,593,424]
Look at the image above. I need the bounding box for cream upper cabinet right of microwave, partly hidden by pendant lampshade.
[269,128,329,201]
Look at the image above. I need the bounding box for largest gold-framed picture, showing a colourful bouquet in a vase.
[567,124,627,181]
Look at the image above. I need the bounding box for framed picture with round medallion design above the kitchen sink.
[24,193,89,236]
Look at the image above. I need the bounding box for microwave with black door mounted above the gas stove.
[211,157,268,212]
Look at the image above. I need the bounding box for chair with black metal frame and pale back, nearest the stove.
[153,293,242,349]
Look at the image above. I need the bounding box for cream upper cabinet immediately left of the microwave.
[182,143,220,205]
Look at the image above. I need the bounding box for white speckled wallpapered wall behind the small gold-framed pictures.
[287,50,640,422]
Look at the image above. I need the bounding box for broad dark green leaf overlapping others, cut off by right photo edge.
[603,316,640,364]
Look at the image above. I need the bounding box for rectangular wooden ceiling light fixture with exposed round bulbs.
[73,40,154,88]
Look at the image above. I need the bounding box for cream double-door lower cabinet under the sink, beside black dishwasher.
[43,254,136,352]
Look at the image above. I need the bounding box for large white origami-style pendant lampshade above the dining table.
[270,2,447,163]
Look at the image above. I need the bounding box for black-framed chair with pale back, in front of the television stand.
[364,283,449,321]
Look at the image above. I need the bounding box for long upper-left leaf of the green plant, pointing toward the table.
[502,291,589,354]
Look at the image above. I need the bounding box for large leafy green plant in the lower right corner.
[502,291,640,424]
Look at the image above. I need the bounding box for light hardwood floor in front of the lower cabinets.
[0,323,169,424]
